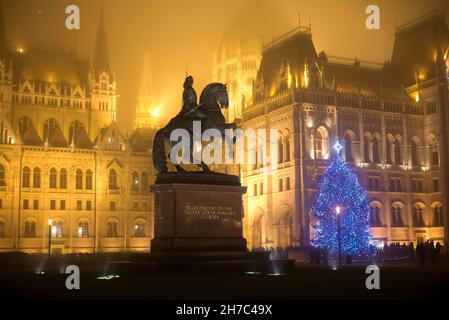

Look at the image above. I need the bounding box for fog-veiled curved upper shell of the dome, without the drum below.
[218,0,297,60]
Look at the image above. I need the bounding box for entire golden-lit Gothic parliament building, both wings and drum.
[0,4,449,253]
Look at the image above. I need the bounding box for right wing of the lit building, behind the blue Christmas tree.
[241,13,449,248]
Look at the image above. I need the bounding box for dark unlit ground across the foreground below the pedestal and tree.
[0,263,449,300]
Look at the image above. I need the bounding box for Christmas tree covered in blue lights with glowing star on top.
[312,141,370,256]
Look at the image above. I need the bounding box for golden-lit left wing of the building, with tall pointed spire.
[0,6,155,253]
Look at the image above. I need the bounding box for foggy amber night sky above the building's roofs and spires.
[3,0,449,133]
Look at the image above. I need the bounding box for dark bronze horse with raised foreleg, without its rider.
[153,83,237,174]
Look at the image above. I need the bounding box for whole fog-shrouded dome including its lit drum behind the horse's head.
[213,0,297,122]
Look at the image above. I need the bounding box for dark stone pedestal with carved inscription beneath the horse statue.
[151,172,247,253]
